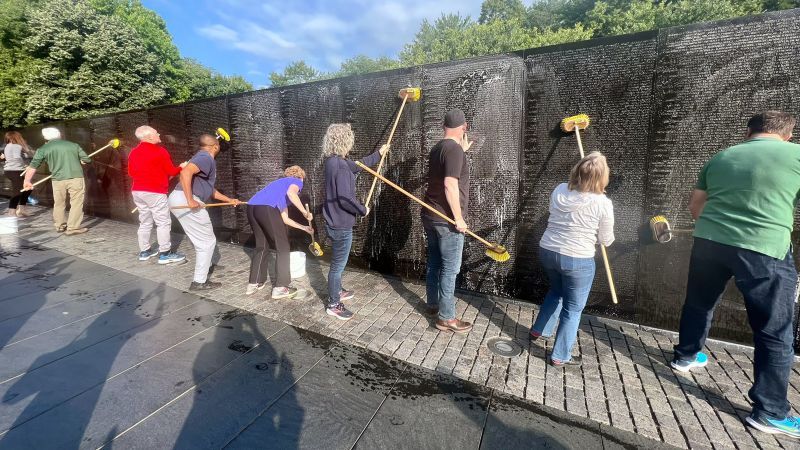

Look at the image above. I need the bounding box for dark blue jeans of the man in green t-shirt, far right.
[675,238,797,420]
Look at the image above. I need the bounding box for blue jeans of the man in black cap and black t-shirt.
[423,219,464,320]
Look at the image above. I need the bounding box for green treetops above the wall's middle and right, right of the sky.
[270,0,800,86]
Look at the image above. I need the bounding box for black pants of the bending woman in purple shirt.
[247,205,292,287]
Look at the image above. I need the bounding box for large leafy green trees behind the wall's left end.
[0,0,252,127]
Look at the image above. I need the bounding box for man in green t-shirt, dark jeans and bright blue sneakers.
[671,111,800,437]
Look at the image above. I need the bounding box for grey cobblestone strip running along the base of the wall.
[1,204,800,449]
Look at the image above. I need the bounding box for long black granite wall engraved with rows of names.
[2,10,800,348]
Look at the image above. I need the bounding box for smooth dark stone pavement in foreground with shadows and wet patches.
[0,236,665,449]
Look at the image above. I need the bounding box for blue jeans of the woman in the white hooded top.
[531,247,595,361]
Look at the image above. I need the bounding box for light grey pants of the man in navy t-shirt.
[169,190,217,283]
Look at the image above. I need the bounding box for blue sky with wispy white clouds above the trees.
[196,0,482,71]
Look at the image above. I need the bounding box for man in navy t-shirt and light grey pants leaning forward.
[169,134,241,291]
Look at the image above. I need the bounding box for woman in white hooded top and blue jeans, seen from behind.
[531,152,614,367]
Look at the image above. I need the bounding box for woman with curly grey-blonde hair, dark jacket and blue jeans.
[322,123,389,320]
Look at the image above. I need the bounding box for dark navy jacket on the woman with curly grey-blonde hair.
[322,152,381,230]
